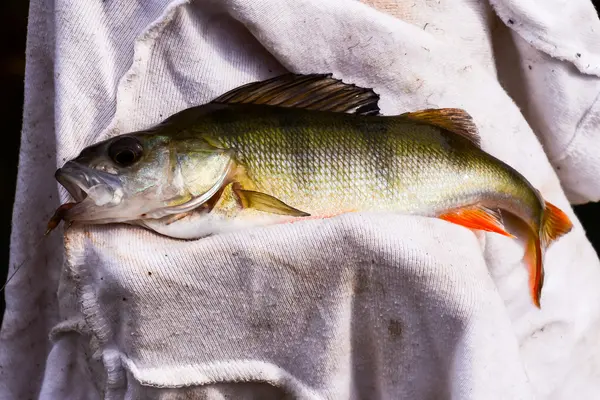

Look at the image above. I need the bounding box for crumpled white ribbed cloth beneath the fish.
[0,0,600,399]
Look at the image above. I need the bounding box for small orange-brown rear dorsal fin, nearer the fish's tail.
[398,108,481,147]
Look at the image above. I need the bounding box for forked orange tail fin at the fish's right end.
[525,201,573,308]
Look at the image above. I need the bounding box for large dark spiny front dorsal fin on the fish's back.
[212,74,379,115]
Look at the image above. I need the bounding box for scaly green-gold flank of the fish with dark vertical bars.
[195,101,516,215]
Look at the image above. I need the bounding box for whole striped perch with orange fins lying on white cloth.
[49,73,573,308]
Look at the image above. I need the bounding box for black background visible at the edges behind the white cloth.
[0,0,600,320]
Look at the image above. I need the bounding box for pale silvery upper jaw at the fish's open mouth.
[54,161,120,203]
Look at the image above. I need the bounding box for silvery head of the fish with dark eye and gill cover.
[55,132,232,224]
